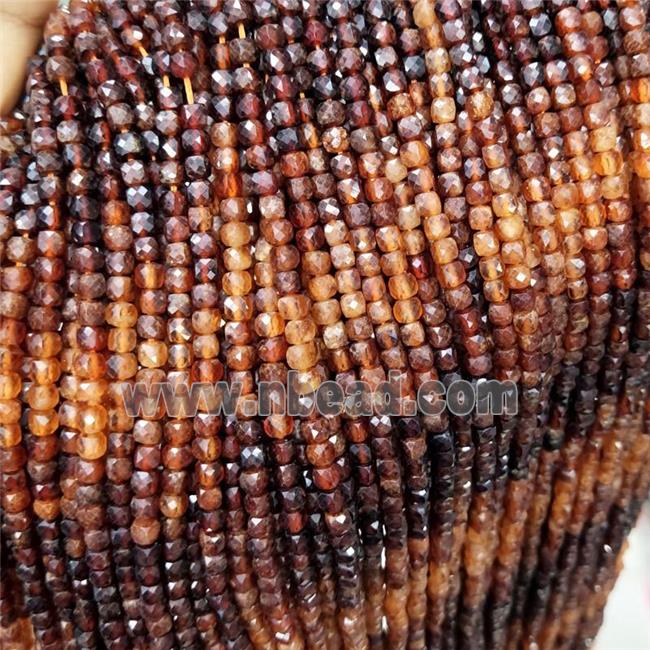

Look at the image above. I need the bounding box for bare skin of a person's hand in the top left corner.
[0,0,57,116]
